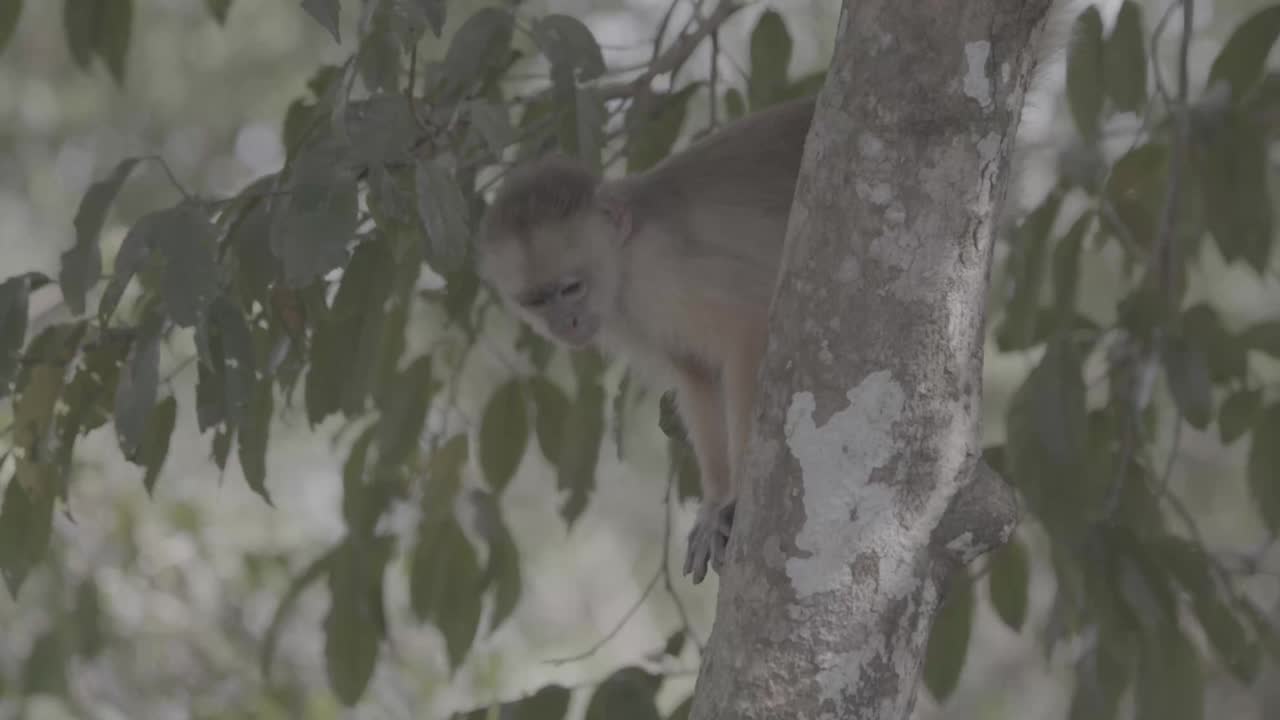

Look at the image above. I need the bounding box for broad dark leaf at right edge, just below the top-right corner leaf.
[1192,113,1280,273]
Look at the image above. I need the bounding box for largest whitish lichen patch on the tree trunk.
[785,370,906,600]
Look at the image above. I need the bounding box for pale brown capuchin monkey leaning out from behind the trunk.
[477,97,814,584]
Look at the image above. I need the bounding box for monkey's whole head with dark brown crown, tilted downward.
[477,158,631,347]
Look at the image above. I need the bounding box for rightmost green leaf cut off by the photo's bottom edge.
[1134,625,1204,720]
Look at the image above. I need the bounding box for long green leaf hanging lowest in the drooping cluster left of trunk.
[324,537,392,707]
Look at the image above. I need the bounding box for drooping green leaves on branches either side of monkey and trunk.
[0,0,1280,719]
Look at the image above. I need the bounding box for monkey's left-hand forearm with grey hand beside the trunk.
[676,368,732,584]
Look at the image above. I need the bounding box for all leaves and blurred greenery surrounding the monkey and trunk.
[0,0,1280,720]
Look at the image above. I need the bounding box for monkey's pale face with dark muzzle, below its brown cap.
[484,210,618,347]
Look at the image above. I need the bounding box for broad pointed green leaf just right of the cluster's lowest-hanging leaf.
[408,516,481,669]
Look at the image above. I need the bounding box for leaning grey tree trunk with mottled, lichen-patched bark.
[692,0,1051,720]
